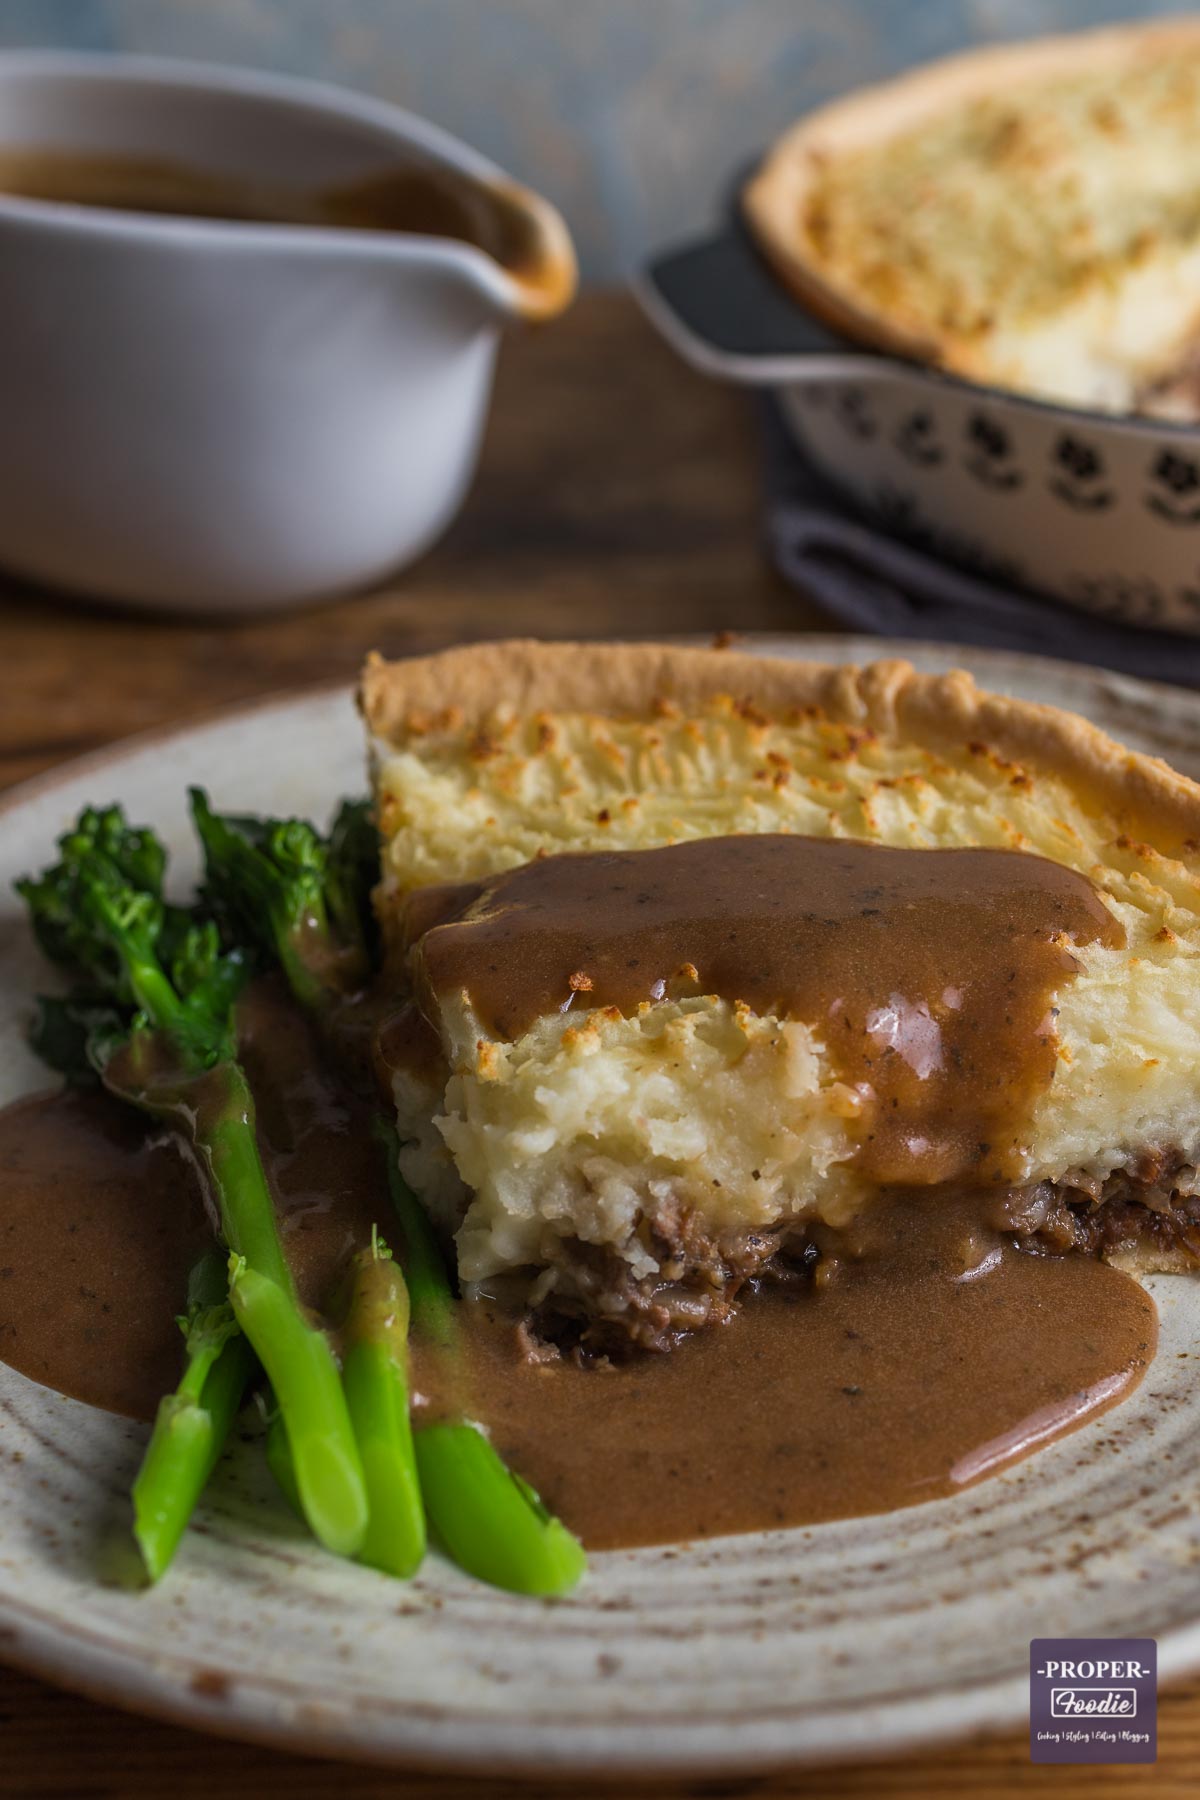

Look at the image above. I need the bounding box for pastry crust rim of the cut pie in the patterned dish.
[741,14,1200,374]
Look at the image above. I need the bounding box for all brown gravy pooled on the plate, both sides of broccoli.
[0,985,1155,1548]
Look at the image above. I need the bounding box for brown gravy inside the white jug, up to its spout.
[0,146,561,283]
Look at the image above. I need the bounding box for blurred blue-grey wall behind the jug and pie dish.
[0,0,1189,279]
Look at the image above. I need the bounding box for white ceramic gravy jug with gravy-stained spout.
[0,52,576,614]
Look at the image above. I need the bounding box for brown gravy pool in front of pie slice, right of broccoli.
[431,1199,1157,1550]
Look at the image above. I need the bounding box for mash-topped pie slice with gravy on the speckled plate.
[362,643,1200,1345]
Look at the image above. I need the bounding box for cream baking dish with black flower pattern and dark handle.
[637,229,1200,634]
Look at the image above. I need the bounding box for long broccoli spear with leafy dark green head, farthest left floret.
[18,806,367,1555]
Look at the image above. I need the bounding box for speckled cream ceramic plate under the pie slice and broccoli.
[0,637,1200,1775]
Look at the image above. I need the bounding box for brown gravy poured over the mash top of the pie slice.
[414,833,1124,1184]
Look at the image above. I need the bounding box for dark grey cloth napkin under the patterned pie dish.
[766,403,1200,686]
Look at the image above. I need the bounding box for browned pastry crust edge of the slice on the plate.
[360,639,1200,855]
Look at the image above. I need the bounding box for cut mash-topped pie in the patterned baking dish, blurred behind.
[745,20,1200,416]
